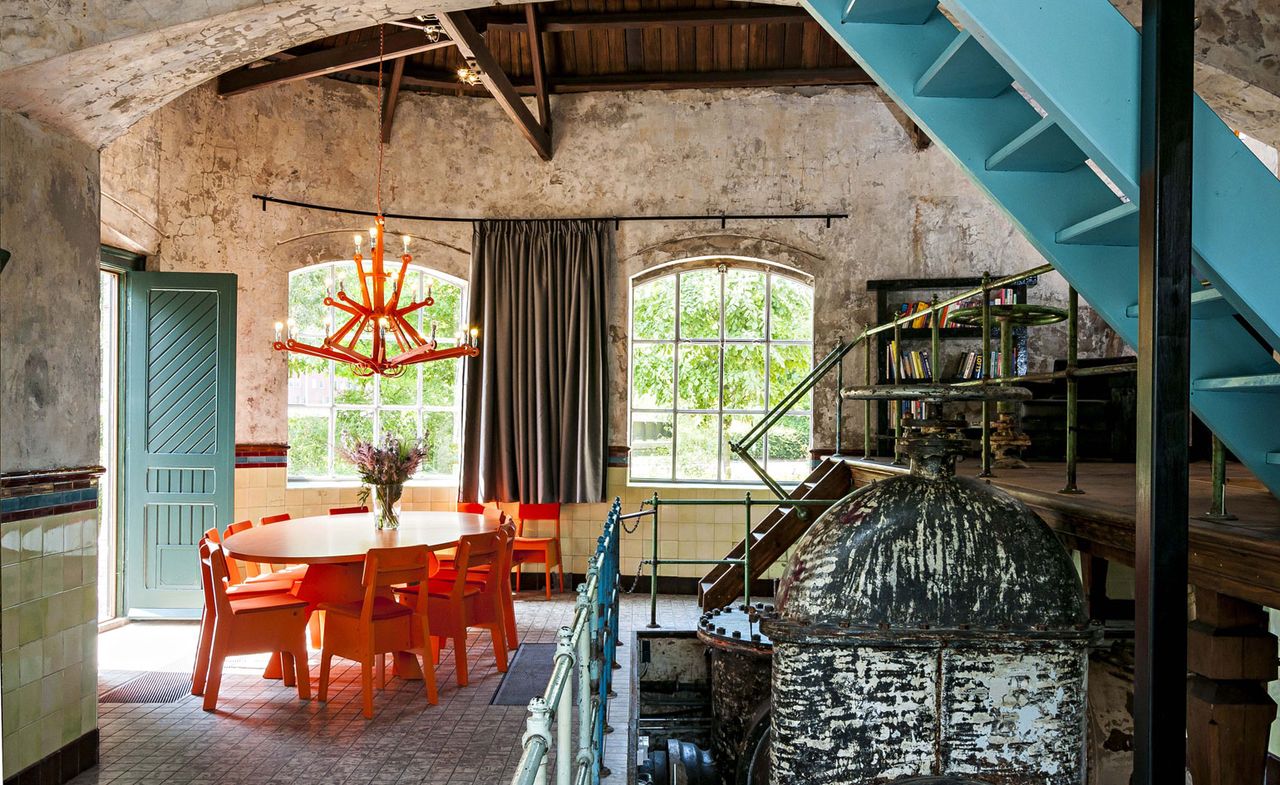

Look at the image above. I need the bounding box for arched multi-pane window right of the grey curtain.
[631,260,813,483]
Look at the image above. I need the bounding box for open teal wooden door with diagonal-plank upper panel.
[120,273,236,619]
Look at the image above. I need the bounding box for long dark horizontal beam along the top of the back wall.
[394,64,874,96]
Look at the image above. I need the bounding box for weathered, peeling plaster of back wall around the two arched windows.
[102,79,1119,447]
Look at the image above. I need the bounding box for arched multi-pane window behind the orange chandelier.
[289,261,466,480]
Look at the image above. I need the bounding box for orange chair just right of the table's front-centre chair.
[396,531,511,686]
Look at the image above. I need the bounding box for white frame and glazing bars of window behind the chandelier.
[288,259,468,484]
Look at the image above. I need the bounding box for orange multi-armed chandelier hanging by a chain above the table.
[271,26,480,376]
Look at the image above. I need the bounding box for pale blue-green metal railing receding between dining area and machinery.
[511,498,623,785]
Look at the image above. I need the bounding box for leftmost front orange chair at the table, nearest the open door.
[192,540,311,712]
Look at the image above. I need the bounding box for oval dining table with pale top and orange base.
[223,511,498,679]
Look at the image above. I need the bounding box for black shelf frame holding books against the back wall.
[867,277,1027,455]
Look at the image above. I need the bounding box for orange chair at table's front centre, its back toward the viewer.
[320,546,439,718]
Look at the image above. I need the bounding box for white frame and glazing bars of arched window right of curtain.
[627,256,814,484]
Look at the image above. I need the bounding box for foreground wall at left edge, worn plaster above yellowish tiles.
[0,110,99,781]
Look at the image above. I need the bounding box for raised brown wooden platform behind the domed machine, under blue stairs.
[846,458,1280,608]
